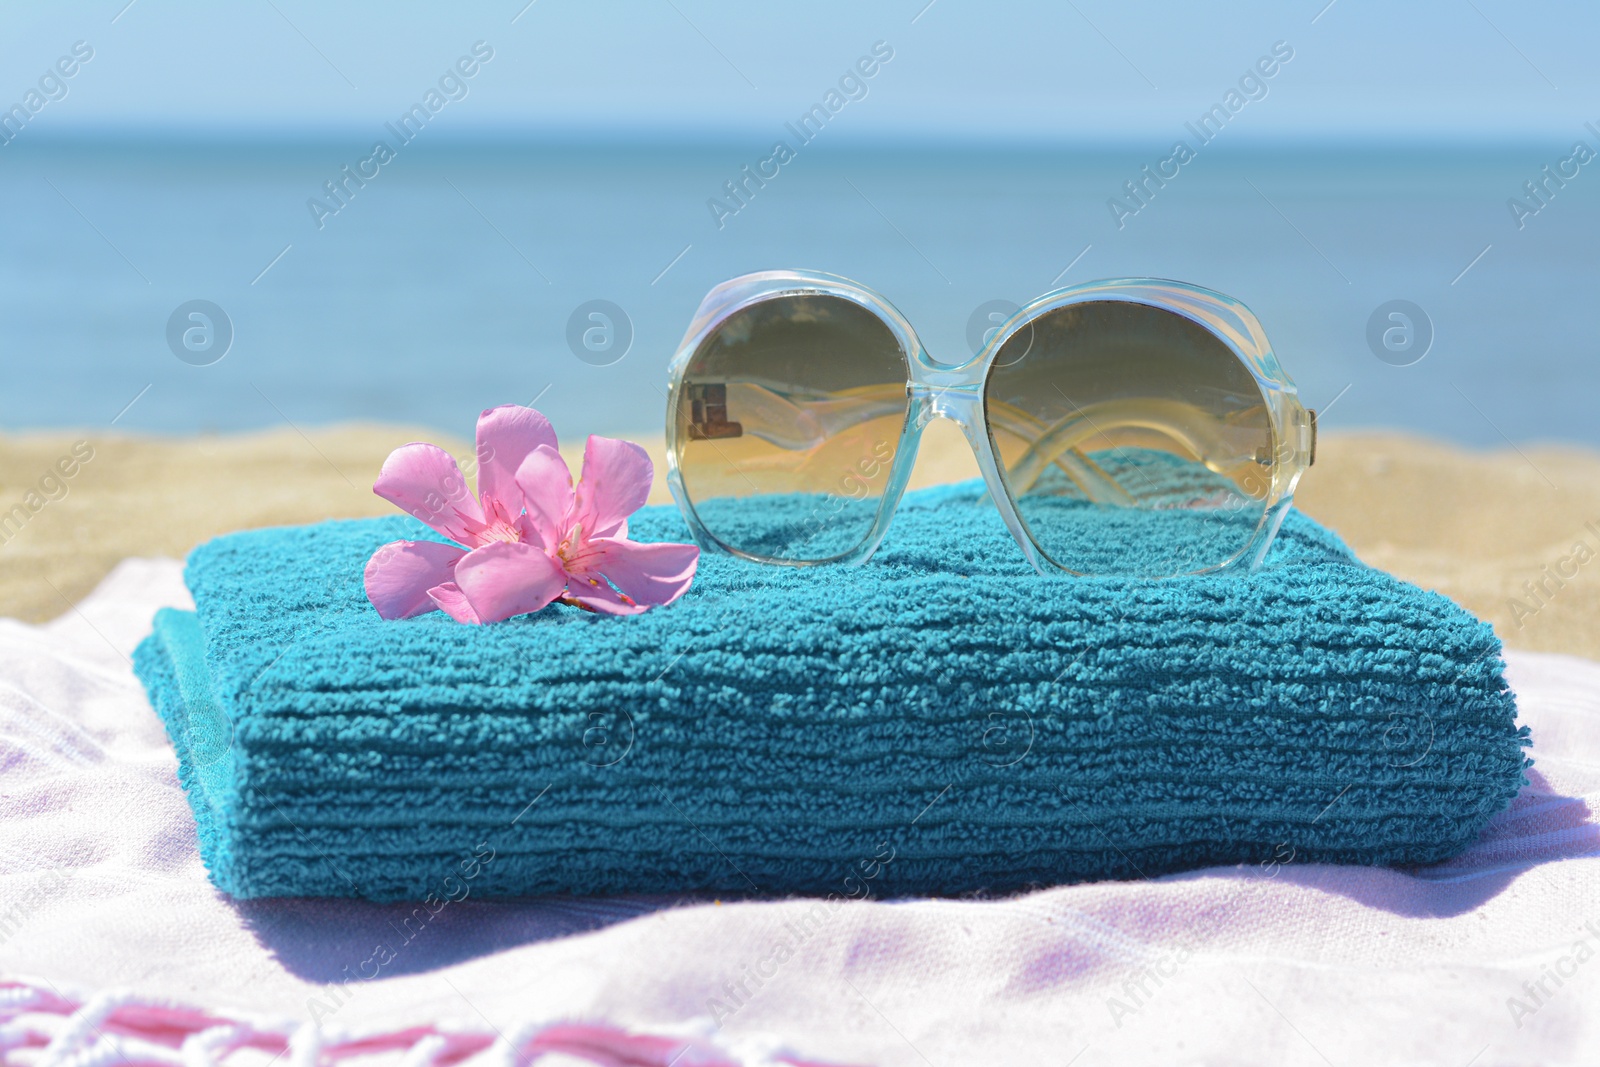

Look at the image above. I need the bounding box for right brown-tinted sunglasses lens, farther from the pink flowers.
[984,301,1272,577]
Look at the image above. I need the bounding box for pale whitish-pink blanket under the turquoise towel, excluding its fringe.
[0,560,1600,1067]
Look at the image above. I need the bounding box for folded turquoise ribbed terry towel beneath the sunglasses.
[134,485,1526,899]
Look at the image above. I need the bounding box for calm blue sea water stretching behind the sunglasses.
[0,136,1600,445]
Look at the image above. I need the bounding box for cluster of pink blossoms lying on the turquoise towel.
[365,405,699,622]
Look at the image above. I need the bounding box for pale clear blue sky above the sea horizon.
[0,0,1600,142]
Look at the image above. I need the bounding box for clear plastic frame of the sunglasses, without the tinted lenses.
[667,270,1317,574]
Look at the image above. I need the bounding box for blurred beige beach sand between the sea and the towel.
[0,424,1600,659]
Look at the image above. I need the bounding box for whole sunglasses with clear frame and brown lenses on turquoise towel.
[667,270,1317,577]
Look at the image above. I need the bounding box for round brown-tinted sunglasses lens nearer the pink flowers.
[674,294,909,561]
